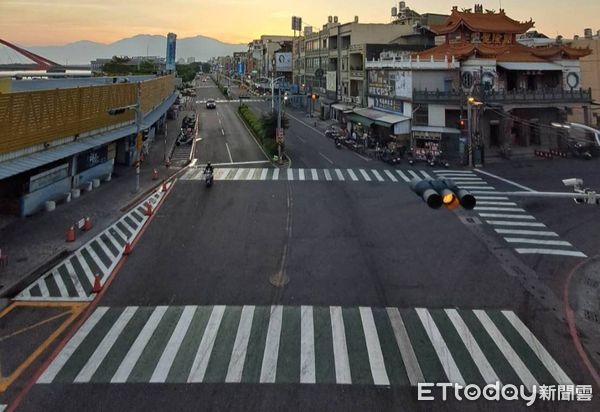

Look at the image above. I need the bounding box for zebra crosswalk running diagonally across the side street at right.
[435,170,587,258]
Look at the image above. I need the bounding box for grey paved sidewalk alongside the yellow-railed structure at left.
[0,111,195,297]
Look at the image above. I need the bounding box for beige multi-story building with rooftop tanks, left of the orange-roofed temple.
[293,2,443,117]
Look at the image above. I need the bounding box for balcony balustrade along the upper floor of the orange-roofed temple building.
[413,89,592,106]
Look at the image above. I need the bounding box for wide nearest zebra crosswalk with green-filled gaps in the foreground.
[37,305,572,387]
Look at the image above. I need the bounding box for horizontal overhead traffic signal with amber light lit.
[410,178,477,210]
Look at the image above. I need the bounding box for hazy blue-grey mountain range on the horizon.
[7,34,248,64]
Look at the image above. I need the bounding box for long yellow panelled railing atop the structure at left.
[0,76,175,154]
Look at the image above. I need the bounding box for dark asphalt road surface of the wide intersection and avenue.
[5,75,599,411]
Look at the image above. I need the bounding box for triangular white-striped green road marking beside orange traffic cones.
[14,182,172,301]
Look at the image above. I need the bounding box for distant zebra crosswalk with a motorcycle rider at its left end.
[181,167,431,183]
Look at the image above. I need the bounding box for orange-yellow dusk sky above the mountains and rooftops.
[0,0,600,46]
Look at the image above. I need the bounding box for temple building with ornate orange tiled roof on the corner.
[366,5,591,159]
